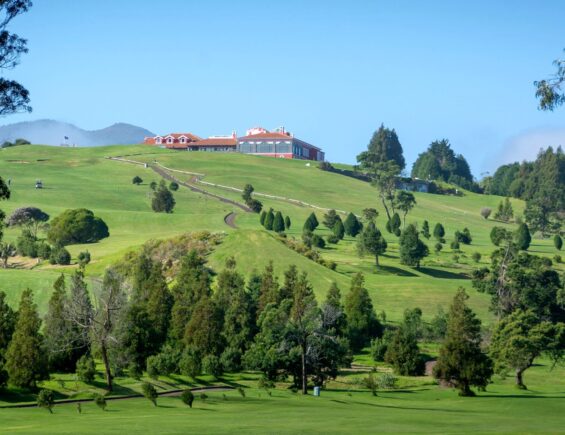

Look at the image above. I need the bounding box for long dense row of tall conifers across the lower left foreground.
[0,251,390,393]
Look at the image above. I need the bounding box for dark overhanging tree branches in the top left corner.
[0,0,32,116]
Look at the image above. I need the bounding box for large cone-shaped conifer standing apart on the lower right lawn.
[434,288,493,396]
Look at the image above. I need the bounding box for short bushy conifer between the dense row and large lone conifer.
[385,325,424,376]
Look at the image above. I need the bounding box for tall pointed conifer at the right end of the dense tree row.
[345,273,382,352]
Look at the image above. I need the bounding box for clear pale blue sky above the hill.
[4,0,565,178]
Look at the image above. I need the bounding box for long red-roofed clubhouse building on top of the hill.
[144,127,324,161]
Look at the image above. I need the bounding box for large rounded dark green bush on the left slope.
[47,208,110,246]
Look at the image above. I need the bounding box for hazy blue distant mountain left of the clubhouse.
[0,119,155,147]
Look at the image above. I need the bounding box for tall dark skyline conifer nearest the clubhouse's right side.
[357,124,406,170]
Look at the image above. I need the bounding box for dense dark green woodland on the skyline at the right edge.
[483,147,565,236]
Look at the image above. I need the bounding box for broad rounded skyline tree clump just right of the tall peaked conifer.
[411,139,474,190]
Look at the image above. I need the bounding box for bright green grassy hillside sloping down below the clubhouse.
[0,145,554,322]
